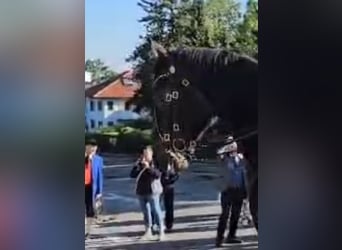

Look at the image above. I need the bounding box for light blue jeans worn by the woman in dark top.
[138,195,164,230]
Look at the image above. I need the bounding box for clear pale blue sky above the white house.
[85,0,247,72]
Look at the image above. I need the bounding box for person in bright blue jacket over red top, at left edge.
[85,139,103,237]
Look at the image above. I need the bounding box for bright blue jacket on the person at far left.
[91,154,103,200]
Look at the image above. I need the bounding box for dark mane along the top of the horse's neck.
[172,48,258,72]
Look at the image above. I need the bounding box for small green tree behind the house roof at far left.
[85,59,117,83]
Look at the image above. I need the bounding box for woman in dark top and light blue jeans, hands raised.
[130,147,165,240]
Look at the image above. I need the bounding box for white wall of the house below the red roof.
[85,98,140,132]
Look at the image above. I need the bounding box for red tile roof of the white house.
[85,71,139,99]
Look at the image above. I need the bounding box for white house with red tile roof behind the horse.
[85,71,141,132]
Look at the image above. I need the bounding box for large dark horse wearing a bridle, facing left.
[151,41,258,229]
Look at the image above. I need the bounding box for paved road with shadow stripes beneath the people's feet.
[86,156,258,250]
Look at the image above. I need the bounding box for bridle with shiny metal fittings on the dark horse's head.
[152,66,257,156]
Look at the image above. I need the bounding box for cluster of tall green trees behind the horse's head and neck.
[127,0,257,110]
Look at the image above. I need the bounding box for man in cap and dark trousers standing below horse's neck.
[216,137,248,247]
